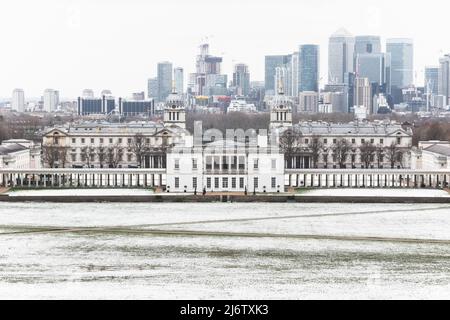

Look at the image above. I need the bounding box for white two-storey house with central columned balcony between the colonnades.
[167,136,284,193]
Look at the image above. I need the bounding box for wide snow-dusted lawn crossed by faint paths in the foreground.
[0,203,450,299]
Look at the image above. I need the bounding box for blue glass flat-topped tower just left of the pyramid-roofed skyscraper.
[299,44,320,92]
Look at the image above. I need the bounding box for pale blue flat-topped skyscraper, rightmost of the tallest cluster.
[386,39,414,89]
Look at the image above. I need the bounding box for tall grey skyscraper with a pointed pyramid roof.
[328,29,355,84]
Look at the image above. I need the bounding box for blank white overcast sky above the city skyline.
[0,0,450,97]
